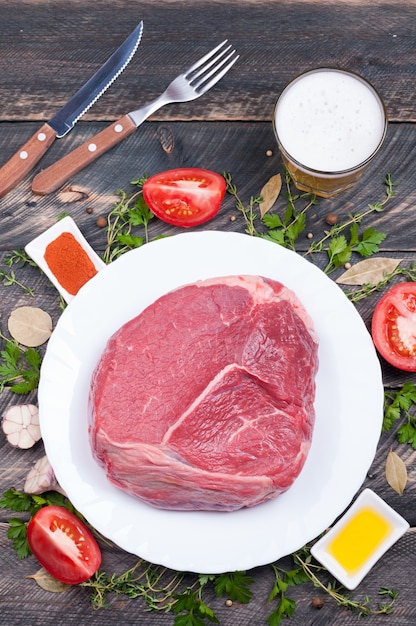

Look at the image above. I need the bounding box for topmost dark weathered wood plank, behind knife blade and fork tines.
[0,0,416,121]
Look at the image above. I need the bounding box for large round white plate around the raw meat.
[39,231,383,573]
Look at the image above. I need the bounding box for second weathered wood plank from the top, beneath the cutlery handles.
[0,122,416,253]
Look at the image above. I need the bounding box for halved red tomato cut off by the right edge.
[371,283,416,372]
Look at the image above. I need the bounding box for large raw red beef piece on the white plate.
[90,276,318,511]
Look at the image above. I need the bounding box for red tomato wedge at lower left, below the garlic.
[27,505,101,585]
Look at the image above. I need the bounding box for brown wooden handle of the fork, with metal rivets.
[32,115,137,196]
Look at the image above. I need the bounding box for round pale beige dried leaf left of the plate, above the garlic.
[7,306,52,348]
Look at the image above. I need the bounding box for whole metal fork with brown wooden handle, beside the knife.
[32,40,239,195]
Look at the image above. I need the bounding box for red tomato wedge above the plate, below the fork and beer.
[143,167,226,228]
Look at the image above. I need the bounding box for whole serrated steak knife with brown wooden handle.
[0,21,143,198]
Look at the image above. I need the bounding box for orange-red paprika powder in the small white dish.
[43,232,98,296]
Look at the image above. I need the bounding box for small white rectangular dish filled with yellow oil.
[311,489,409,589]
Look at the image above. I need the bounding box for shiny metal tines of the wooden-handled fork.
[184,39,240,93]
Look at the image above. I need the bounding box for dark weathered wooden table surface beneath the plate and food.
[0,0,416,626]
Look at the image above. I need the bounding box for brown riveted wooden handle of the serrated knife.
[0,124,56,198]
